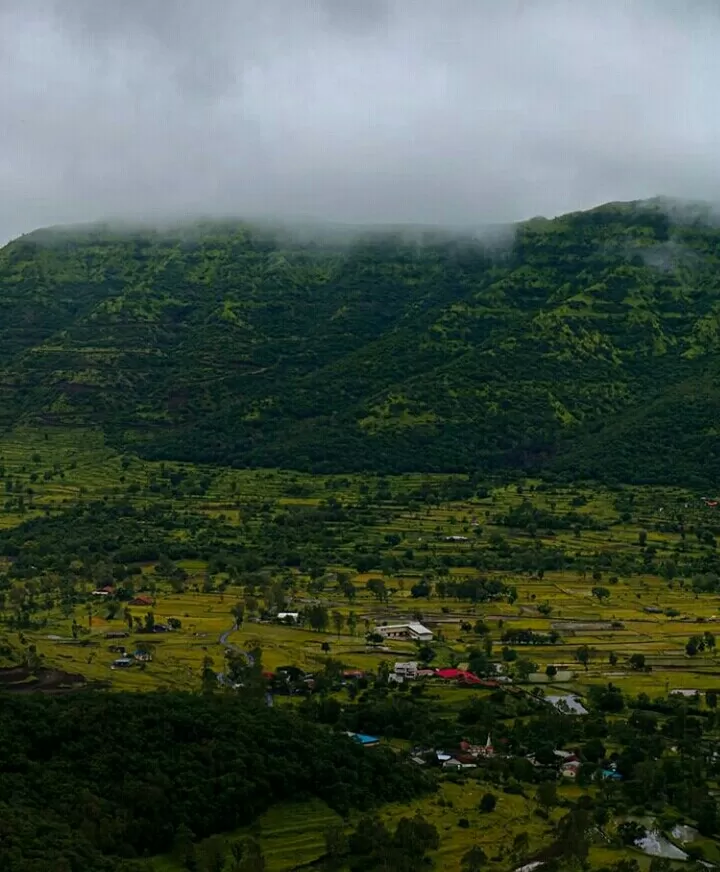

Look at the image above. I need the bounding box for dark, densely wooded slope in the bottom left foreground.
[0,692,431,872]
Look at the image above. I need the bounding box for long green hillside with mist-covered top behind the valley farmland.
[0,202,720,486]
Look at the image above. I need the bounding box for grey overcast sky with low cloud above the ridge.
[0,0,720,241]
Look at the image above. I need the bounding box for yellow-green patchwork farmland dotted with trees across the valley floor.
[0,429,720,872]
